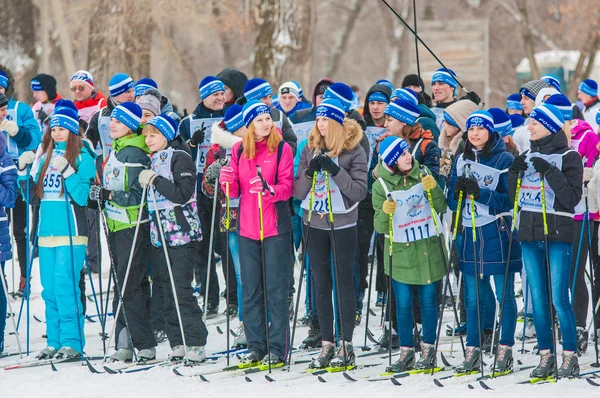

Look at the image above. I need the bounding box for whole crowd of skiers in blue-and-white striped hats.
[0,62,600,377]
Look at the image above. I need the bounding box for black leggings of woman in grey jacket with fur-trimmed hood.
[307,226,358,342]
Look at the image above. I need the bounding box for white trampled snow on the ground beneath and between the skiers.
[0,243,600,398]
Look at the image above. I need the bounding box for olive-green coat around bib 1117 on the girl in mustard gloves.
[373,160,447,285]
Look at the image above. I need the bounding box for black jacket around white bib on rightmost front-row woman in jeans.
[508,130,583,242]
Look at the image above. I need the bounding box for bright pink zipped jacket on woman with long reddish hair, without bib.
[221,138,294,240]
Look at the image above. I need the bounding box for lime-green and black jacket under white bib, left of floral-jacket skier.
[106,134,150,232]
